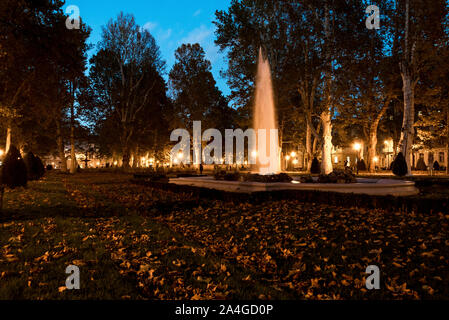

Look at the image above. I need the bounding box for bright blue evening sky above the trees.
[64,0,230,95]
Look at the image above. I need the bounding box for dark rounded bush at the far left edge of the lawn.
[2,146,28,189]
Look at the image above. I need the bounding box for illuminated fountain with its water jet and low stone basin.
[166,49,419,196]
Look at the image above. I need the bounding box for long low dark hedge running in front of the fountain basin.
[132,180,449,214]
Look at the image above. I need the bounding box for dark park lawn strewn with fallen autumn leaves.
[0,172,449,300]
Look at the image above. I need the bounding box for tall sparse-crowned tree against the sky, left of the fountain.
[90,13,165,169]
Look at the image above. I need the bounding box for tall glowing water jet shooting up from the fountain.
[253,48,281,175]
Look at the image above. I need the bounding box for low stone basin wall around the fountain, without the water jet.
[169,177,419,196]
